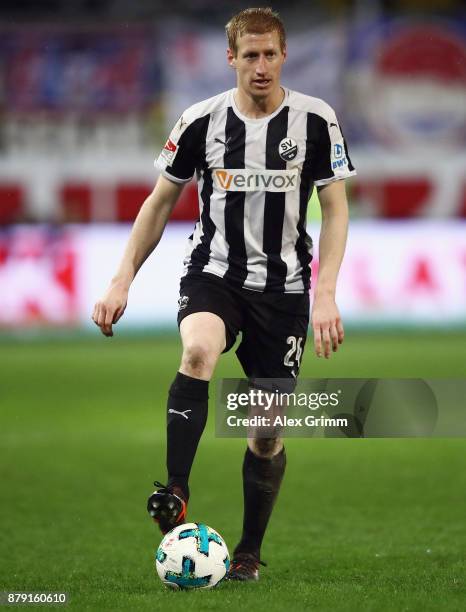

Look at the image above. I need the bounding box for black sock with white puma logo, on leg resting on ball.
[167,372,209,500]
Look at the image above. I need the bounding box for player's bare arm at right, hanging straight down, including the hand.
[311,180,348,359]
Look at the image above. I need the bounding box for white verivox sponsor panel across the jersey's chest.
[214,168,298,192]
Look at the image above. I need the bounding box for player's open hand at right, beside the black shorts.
[311,296,345,359]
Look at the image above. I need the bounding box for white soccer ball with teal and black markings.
[155,523,230,589]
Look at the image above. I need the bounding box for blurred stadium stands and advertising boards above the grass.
[0,0,466,330]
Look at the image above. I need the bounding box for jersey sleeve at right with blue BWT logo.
[313,107,356,187]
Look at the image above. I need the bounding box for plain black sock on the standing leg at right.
[235,448,286,557]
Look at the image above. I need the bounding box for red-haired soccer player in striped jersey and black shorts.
[93,8,355,580]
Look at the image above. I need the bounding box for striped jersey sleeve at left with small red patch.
[154,116,197,183]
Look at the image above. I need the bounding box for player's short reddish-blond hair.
[225,7,286,55]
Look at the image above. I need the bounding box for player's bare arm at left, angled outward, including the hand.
[92,175,184,336]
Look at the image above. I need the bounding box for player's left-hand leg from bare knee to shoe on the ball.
[147,312,226,533]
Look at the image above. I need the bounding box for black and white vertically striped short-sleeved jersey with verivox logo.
[156,88,355,293]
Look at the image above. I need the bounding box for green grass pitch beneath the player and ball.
[0,332,466,612]
